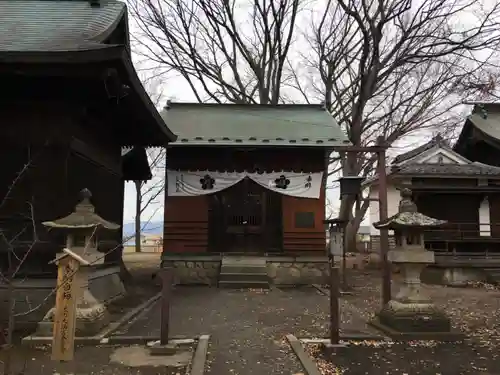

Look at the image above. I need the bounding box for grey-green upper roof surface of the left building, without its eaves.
[0,0,126,52]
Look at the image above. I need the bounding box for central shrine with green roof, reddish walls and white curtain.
[162,103,349,255]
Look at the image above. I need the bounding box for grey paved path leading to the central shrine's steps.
[114,287,378,375]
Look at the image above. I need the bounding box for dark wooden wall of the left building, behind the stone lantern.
[0,100,123,272]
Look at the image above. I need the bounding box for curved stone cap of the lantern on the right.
[373,188,446,230]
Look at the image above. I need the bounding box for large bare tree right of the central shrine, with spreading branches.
[293,0,500,253]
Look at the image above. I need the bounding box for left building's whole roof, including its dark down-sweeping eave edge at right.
[0,0,176,146]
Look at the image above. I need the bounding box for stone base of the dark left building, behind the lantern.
[0,266,125,330]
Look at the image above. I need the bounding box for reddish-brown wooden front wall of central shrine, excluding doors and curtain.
[164,146,326,254]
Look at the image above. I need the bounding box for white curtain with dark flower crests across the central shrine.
[167,170,323,198]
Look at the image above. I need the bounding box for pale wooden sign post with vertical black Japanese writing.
[52,256,80,361]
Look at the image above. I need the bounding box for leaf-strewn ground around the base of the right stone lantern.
[307,272,500,375]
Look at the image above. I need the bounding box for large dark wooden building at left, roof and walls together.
[0,0,175,324]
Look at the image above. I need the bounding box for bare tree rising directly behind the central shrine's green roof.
[128,0,300,104]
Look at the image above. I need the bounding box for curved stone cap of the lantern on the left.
[42,189,120,230]
